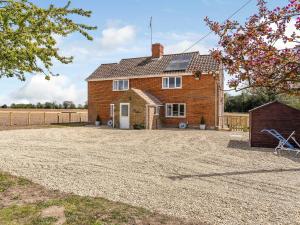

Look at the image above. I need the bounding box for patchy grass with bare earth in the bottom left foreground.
[0,172,195,225]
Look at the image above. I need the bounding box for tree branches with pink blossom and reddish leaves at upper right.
[205,0,300,95]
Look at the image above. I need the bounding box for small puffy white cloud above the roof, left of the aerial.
[100,25,136,49]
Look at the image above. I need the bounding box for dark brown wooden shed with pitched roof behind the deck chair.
[249,101,300,148]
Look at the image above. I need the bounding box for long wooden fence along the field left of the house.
[0,110,88,126]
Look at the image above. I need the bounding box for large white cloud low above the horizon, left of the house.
[6,75,86,104]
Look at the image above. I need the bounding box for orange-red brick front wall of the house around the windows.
[88,75,218,128]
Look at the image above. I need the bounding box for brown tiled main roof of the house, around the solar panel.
[87,52,220,80]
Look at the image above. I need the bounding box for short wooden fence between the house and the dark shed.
[220,113,249,131]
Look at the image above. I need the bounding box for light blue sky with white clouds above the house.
[0,0,287,105]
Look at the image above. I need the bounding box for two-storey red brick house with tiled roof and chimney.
[86,44,224,129]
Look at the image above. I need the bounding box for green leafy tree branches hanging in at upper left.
[0,0,96,80]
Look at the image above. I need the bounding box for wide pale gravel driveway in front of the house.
[0,127,300,224]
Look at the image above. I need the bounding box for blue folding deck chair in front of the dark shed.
[261,129,300,156]
